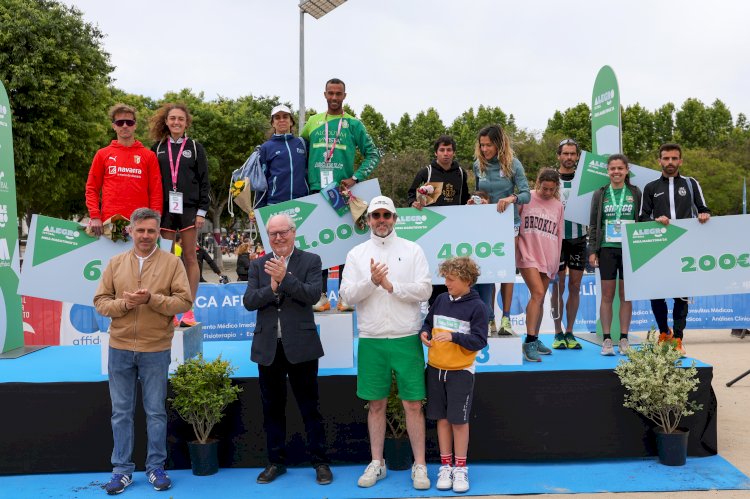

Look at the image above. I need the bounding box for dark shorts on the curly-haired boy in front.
[424,365,474,424]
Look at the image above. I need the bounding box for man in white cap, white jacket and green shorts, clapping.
[339,196,432,490]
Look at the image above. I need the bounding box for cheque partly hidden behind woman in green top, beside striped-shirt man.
[565,151,661,225]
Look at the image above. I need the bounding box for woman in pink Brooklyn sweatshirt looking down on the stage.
[516,168,564,362]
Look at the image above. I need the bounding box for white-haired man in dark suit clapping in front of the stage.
[243,214,333,485]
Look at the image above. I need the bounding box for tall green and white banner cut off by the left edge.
[0,77,23,352]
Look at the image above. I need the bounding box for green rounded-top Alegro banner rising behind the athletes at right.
[591,66,622,155]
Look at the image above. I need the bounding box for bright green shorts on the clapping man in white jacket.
[357,334,425,400]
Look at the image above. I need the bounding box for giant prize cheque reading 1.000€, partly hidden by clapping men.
[257,179,380,269]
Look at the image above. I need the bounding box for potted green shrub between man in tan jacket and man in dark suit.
[169,354,242,476]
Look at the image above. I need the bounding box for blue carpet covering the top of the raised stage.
[0,334,708,383]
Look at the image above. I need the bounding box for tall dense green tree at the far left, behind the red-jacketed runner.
[0,0,113,221]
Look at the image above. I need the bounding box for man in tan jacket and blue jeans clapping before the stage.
[94,208,193,495]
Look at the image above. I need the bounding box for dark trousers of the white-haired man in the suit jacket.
[258,340,330,466]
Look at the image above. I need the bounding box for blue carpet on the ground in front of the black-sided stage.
[0,456,750,499]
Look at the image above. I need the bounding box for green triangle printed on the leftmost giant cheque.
[32,215,96,266]
